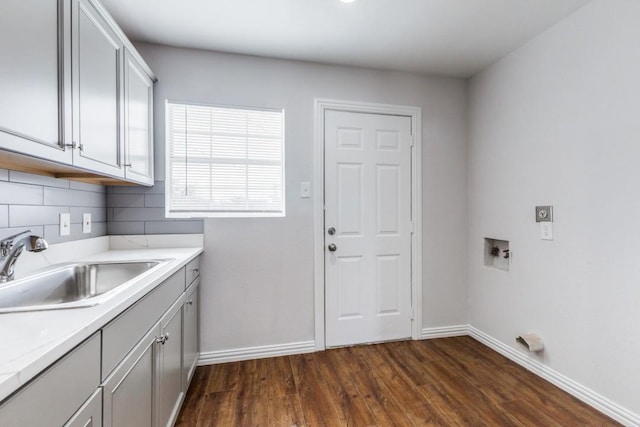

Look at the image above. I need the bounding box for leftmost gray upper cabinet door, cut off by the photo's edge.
[0,0,72,163]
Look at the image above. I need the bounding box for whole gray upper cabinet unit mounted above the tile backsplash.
[0,0,155,185]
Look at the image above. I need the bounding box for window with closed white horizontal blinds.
[165,101,285,218]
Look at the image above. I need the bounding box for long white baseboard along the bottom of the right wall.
[468,326,640,426]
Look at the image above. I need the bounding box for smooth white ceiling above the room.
[102,0,589,77]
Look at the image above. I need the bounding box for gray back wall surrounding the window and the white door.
[135,44,467,352]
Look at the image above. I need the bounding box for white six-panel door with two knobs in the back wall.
[324,111,412,347]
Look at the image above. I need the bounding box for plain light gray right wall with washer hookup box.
[468,0,640,414]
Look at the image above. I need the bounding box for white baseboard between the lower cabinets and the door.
[198,341,316,366]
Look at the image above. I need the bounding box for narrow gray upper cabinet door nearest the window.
[124,50,153,185]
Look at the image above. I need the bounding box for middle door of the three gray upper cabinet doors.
[72,0,124,177]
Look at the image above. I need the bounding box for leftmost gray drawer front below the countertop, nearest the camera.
[0,332,100,427]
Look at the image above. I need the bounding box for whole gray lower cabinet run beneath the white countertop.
[0,258,200,427]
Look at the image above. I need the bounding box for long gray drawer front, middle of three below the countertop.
[102,268,185,380]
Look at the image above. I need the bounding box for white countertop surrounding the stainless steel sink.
[0,239,202,401]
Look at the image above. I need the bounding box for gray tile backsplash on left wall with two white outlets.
[0,169,107,243]
